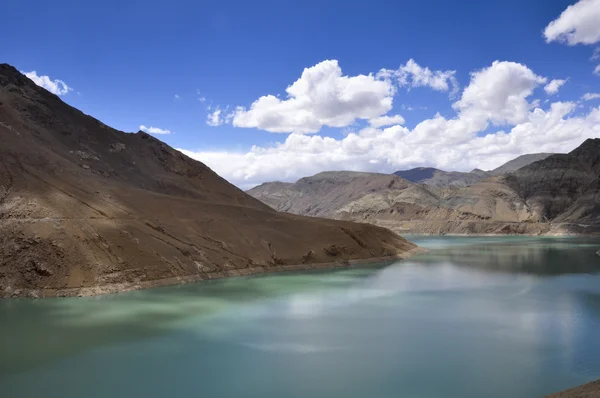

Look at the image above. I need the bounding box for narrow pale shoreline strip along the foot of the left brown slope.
[0,246,427,299]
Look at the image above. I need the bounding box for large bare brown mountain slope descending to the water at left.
[0,64,419,296]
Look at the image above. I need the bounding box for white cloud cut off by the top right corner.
[544,0,600,46]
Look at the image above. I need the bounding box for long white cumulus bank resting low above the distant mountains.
[176,62,600,189]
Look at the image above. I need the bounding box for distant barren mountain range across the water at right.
[248,146,600,234]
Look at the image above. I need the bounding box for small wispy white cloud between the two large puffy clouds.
[377,58,459,95]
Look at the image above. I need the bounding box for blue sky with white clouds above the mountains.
[0,0,600,189]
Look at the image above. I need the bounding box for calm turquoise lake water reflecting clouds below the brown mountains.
[0,237,600,398]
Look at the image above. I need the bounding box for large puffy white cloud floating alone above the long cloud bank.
[233,60,395,134]
